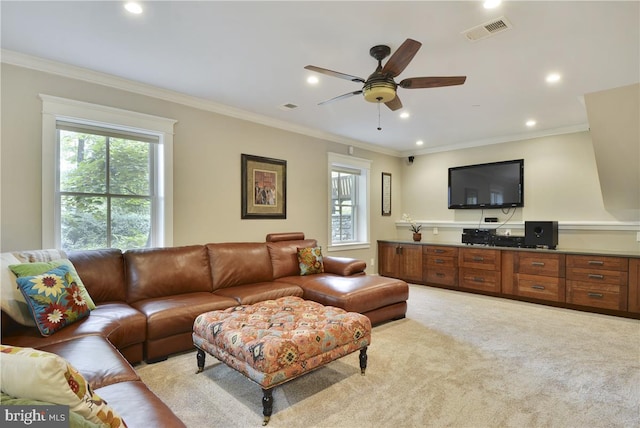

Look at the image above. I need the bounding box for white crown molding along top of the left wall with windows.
[0,49,401,157]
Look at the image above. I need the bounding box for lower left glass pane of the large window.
[60,195,108,250]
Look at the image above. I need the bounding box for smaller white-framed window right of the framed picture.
[329,153,371,250]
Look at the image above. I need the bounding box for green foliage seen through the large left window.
[59,129,153,250]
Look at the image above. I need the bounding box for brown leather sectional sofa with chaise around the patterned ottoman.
[2,233,409,428]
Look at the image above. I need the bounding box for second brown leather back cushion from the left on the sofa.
[124,245,213,303]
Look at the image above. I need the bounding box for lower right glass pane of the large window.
[111,198,151,248]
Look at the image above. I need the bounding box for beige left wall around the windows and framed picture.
[0,64,401,270]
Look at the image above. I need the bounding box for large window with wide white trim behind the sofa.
[40,95,175,250]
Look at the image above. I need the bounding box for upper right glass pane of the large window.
[109,138,151,196]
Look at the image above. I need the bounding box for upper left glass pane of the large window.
[59,130,107,193]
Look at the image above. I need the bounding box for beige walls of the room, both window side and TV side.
[0,64,640,272]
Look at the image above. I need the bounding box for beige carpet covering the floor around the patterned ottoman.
[136,285,640,428]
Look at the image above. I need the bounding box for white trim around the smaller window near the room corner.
[327,152,371,251]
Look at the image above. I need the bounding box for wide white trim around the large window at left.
[39,94,177,248]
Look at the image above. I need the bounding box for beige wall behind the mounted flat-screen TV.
[398,132,640,251]
